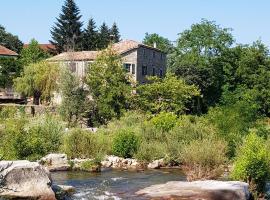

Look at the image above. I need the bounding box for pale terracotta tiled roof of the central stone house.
[48,40,160,61]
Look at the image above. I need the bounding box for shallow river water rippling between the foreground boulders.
[52,169,186,200]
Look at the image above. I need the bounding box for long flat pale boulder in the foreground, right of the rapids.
[136,181,250,200]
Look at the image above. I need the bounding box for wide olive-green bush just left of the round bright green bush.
[63,128,111,158]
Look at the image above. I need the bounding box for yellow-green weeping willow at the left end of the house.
[14,61,59,105]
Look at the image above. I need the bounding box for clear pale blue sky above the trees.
[0,0,270,46]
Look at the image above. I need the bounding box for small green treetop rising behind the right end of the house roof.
[143,33,174,53]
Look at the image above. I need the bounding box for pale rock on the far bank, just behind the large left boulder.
[40,154,70,172]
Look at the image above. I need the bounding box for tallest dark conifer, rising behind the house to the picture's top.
[50,0,83,53]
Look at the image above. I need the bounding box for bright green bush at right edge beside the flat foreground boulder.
[231,133,270,193]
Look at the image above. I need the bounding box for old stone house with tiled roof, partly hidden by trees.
[48,40,167,84]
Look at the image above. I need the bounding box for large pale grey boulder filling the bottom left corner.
[0,161,56,200]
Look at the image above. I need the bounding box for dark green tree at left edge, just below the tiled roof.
[0,58,22,88]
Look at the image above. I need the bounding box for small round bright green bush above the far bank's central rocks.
[112,130,139,158]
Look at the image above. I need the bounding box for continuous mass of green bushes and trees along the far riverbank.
[0,3,270,195]
